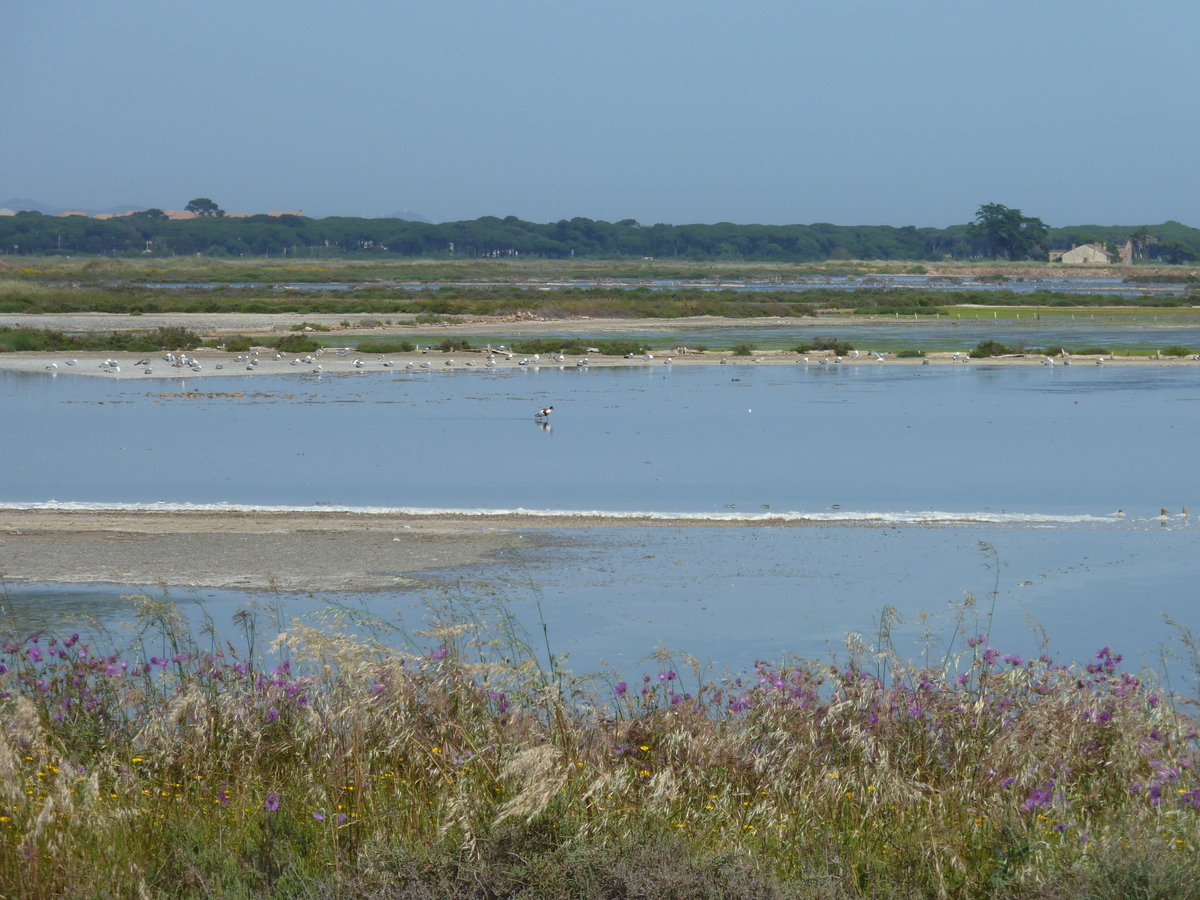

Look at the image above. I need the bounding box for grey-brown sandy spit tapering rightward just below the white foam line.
[0,509,844,592]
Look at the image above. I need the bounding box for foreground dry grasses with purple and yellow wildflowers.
[0,588,1200,900]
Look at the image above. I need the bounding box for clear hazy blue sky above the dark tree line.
[0,0,1200,226]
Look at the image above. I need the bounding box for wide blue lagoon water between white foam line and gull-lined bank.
[0,364,1200,517]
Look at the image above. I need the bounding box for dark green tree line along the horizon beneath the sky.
[0,200,1200,263]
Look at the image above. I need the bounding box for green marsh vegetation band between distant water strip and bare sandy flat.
[0,274,1196,324]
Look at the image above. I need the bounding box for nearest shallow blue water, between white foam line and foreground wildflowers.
[5,521,1200,676]
